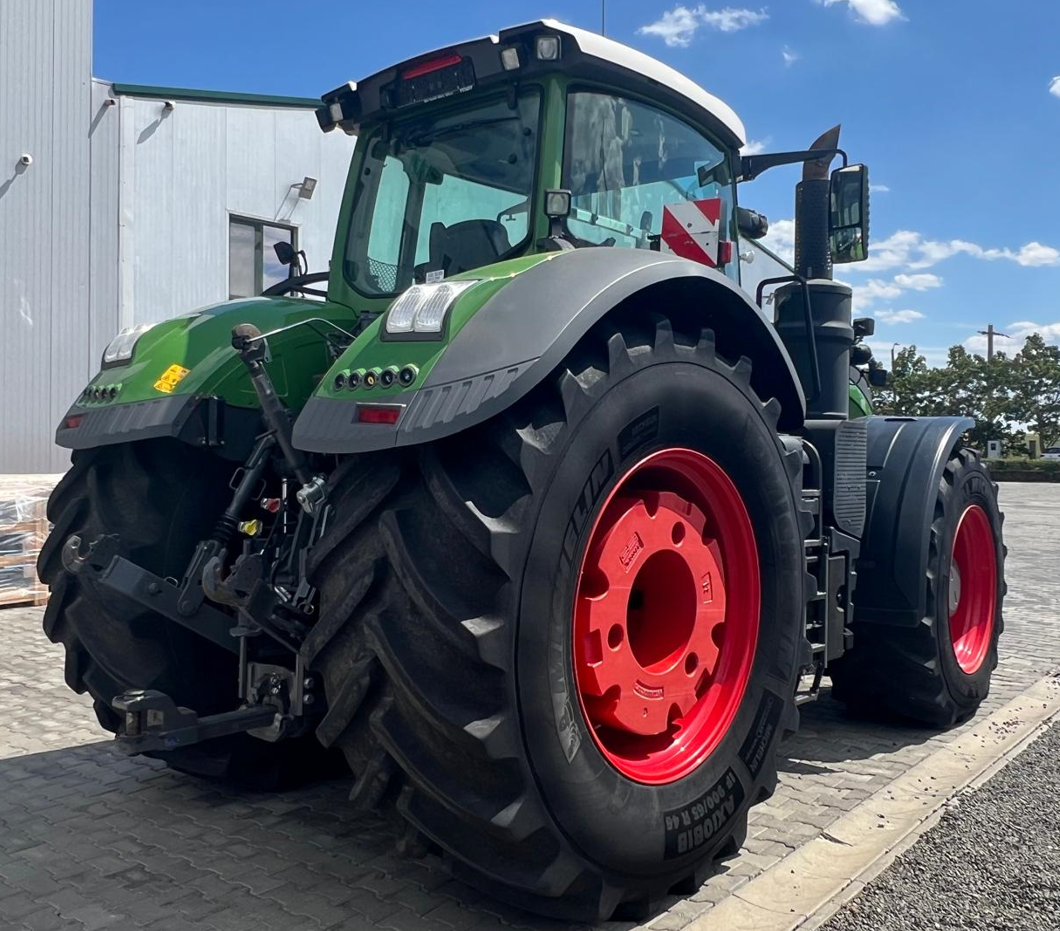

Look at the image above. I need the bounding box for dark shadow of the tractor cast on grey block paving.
[0,692,935,931]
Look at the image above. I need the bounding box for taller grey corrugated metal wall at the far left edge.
[0,0,98,472]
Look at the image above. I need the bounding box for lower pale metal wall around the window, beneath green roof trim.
[119,96,353,326]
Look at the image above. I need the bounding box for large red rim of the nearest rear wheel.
[573,449,760,785]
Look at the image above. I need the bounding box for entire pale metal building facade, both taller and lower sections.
[0,0,353,473]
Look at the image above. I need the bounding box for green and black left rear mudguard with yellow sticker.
[55,297,355,459]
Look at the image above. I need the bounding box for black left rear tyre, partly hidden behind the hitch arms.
[38,440,337,789]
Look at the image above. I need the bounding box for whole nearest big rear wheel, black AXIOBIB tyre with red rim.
[305,315,805,920]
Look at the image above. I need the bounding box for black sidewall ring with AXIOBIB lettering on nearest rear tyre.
[516,353,803,877]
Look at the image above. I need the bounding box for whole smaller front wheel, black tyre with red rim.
[829,446,1006,727]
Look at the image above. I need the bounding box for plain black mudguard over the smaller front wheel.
[854,417,975,627]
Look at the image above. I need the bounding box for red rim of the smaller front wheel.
[947,505,997,675]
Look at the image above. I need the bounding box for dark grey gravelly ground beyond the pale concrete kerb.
[823,712,1060,931]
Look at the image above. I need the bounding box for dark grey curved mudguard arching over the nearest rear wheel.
[294,248,806,453]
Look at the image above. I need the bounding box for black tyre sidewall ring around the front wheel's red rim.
[929,459,1004,706]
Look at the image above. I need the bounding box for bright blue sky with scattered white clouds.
[94,0,1060,362]
